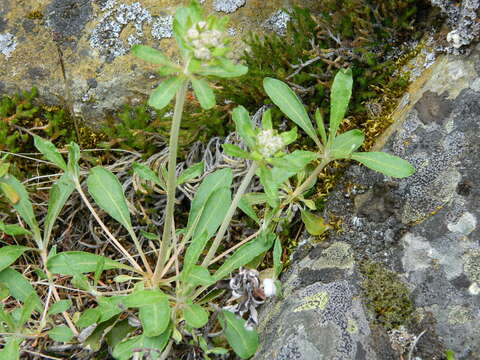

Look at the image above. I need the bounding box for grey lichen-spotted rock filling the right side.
[255,46,480,360]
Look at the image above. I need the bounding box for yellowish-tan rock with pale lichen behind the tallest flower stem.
[0,0,314,126]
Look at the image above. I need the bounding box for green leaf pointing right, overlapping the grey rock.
[352,152,415,178]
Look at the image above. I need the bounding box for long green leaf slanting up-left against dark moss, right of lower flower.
[263,77,320,144]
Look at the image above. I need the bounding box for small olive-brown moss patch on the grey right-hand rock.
[359,261,414,329]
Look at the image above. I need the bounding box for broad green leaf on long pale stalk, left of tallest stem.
[87,166,133,231]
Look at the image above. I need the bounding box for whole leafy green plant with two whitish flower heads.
[0,1,414,360]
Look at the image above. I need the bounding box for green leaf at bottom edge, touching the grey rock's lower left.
[221,310,258,359]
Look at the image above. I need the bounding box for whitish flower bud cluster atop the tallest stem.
[187,21,223,60]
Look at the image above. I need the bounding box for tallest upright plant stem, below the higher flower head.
[153,80,189,285]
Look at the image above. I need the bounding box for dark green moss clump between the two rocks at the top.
[221,0,426,142]
